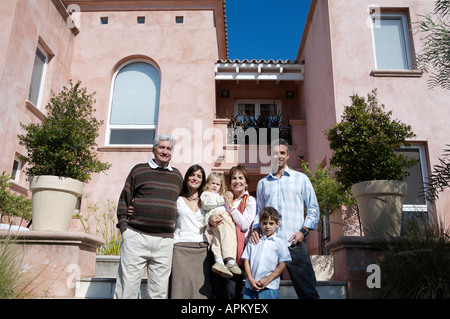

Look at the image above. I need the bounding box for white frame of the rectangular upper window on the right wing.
[371,12,414,70]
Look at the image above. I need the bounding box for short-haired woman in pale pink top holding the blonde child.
[209,165,256,299]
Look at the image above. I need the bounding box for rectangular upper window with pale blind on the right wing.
[372,13,413,70]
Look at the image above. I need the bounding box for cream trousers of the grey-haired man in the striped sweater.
[114,228,174,299]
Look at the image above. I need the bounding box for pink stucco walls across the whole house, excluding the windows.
[0,0,450,238]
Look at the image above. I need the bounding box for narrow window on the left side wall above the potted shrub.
[28,46,48,108]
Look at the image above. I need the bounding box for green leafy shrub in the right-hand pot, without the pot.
[325,90,416,188]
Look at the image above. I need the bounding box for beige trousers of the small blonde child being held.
[211,211,237,260]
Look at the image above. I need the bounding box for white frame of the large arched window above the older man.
[105,59,159,147]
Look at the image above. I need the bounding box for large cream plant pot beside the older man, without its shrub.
[30,175,83,231]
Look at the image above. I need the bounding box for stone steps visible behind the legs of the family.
[75,255,347,299]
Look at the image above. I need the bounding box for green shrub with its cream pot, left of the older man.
[18,81,111,231]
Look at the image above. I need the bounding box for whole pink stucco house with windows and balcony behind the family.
[0,0,450,298]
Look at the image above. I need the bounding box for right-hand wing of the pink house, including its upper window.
[297,0,450,249]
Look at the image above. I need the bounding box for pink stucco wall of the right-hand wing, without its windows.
[298,0,450,238]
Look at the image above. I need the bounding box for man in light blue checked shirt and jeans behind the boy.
[249,139,320,299]
